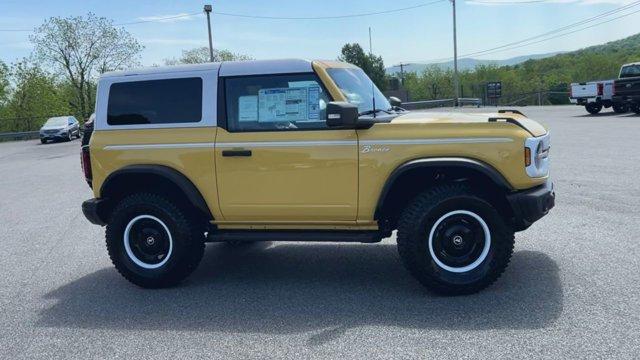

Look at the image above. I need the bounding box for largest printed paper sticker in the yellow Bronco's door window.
[258,87,320,122]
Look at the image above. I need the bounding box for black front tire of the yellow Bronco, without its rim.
[397,184,514,295]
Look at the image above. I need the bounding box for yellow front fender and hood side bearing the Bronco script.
[358,120,547,221]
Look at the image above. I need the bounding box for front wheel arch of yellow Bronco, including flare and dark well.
[374,157,513,229]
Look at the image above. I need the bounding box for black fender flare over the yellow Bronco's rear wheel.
[100,165,213,219]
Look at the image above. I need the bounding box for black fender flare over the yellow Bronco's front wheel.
[374,157,513,219]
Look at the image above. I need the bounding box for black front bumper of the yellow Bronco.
[507,181,556,231]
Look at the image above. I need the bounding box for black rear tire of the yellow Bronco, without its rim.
[106,193,205,288]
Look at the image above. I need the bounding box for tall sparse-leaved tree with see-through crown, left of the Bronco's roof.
[30,13,142,117]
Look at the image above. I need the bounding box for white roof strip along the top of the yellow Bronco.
[101,59,312,78]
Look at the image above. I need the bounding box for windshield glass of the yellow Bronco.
[327,68,391,113]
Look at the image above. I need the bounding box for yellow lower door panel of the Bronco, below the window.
[215,129,358,225]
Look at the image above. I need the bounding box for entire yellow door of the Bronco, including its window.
[215,73,358,224]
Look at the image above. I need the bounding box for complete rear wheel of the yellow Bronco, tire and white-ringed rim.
[106,193,205,288]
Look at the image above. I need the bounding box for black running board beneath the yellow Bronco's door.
[207,230,382,243]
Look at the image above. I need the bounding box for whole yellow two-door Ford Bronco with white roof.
[81,60,555,294]
